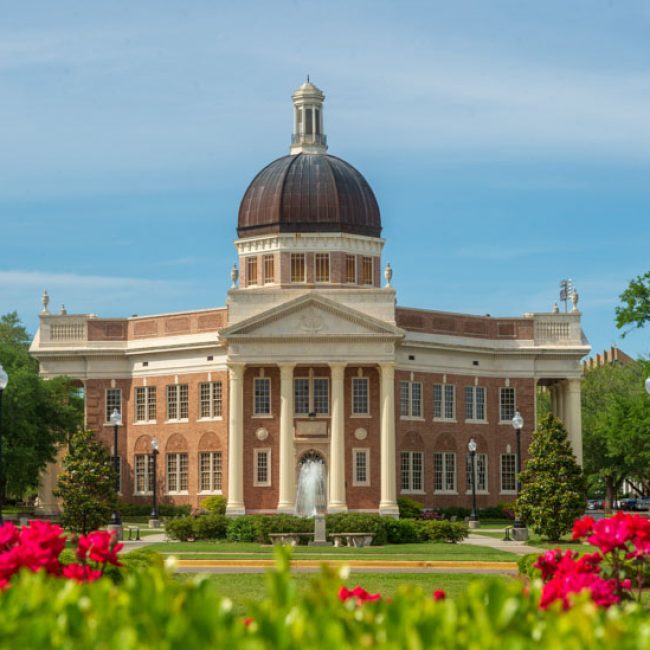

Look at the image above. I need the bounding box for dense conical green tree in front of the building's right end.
[516,415,587,541]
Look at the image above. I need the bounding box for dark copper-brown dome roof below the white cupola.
[237,153,381,237]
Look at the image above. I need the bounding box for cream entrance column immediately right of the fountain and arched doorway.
[327,363,348,513]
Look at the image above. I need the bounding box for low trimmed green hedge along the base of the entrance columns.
[165,513,467,546]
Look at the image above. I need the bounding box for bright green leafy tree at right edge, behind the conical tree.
[582,360,650,508]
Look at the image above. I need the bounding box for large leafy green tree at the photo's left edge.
[0,312,83,498]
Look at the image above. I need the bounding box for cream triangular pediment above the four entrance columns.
[221,295,404,340]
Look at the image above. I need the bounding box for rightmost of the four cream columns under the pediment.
[379,363,399,517]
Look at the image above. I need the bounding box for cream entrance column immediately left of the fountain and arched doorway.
[278,363,296,514]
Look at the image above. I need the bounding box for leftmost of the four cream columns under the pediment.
[226,364,246,516]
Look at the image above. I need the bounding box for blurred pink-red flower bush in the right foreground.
[533,512,650,609]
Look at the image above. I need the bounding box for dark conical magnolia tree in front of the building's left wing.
[54,431,117,534]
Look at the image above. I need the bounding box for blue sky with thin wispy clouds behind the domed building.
[0,0,650,355]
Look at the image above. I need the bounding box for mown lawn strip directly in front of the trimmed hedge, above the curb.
[149,542,517,562]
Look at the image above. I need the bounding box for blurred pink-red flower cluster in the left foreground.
[0,520,123,589]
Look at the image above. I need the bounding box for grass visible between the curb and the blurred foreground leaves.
[179,572,506,614]
